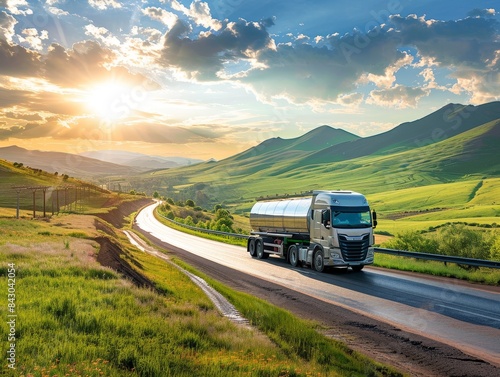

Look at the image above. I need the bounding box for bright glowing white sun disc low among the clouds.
[85,81,131,121]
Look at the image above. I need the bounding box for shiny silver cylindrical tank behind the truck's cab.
[250,198,312,233]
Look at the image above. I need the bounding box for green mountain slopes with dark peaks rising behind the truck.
[138,102,500,204]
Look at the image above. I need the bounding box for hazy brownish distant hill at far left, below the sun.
[0,145,139,178]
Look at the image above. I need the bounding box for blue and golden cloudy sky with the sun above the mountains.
[0,0,500,160]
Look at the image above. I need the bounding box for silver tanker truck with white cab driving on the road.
[247,191,377,272]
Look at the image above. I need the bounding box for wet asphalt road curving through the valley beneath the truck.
[136,204,500,366]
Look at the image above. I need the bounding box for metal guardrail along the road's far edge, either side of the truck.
[158,213,500,268]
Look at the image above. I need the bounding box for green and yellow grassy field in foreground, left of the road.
[0,207,398,376]
